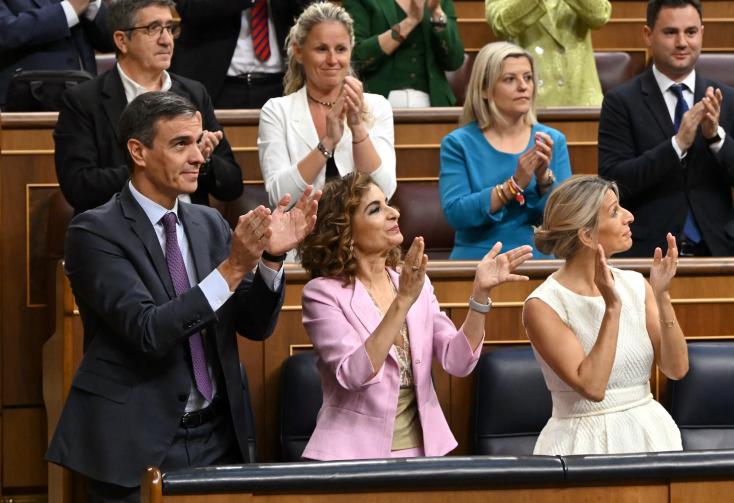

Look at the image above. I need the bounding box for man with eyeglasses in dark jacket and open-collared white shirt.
[54,0,242,213]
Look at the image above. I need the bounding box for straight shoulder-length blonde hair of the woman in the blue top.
[459,42,538,131]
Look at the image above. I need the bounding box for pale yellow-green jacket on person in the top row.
[484,0,612,107]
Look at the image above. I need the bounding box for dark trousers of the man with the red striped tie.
[214,73,283,108]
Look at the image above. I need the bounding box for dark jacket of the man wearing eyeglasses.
[54,67,242,213]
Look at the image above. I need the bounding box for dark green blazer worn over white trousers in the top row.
[343,0,464,107]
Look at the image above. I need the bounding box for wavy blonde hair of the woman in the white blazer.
[283,2,354,95]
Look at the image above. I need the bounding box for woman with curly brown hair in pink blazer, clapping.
[299,173,532,460]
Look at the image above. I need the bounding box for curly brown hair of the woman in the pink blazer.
[297,172,401,285]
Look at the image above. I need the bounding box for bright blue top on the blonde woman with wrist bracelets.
[438,122,571,260]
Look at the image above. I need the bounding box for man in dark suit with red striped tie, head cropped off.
[172,0,313,109]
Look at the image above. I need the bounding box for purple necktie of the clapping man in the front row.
[161,212,213,402]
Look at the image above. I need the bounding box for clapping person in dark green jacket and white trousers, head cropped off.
[343,0,464,107]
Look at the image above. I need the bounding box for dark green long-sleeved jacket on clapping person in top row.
[343,0,464,107]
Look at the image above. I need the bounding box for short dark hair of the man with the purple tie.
[120,91,198,152]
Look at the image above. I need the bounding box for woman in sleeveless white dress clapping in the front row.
[523,176,688,455]
